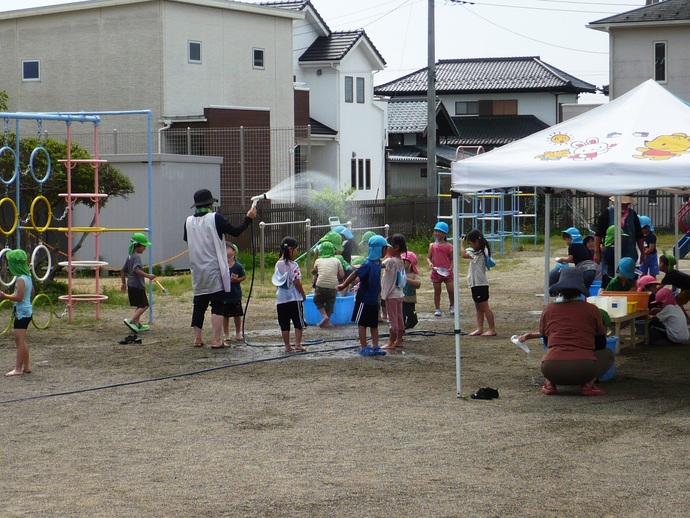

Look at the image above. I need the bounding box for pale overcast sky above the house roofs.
[0,0,645,102]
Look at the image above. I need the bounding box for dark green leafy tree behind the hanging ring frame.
[0,133,134,276]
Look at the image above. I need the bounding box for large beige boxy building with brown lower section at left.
[0,0,304,211]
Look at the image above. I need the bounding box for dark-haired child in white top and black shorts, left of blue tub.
[271,236,307,353]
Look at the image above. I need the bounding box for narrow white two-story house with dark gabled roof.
[262,0,386,200]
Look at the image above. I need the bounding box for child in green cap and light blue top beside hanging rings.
[0,249,34,377]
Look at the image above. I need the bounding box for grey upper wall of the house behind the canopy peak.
[610,25,690,101]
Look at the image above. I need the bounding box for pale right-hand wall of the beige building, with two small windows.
[164,2,294,128]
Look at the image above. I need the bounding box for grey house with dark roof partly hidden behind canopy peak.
[587,0,690,101]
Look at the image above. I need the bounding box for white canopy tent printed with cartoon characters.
[451,79,690,396]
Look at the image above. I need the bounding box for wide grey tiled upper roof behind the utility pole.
[374,56,596,97]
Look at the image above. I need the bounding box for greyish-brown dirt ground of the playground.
[0,252,690,517]
